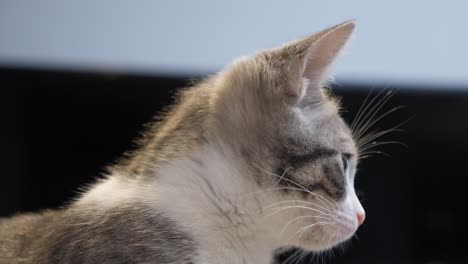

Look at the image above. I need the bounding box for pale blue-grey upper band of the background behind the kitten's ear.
[0,0,468,88]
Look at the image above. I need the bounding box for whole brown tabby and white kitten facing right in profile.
[0,21,364,264]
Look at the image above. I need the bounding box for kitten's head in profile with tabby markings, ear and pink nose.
[212,21,365,250]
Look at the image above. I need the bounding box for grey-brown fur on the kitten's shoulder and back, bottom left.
[0,204,196,264]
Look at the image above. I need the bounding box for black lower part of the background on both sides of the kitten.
[0,67,468,264]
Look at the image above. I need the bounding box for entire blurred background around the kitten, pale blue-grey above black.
[0,0,468,264]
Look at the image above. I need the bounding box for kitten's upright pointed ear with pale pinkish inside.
[270,21,355,104]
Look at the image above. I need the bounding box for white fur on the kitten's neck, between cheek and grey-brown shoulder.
[155,145,279,264]
